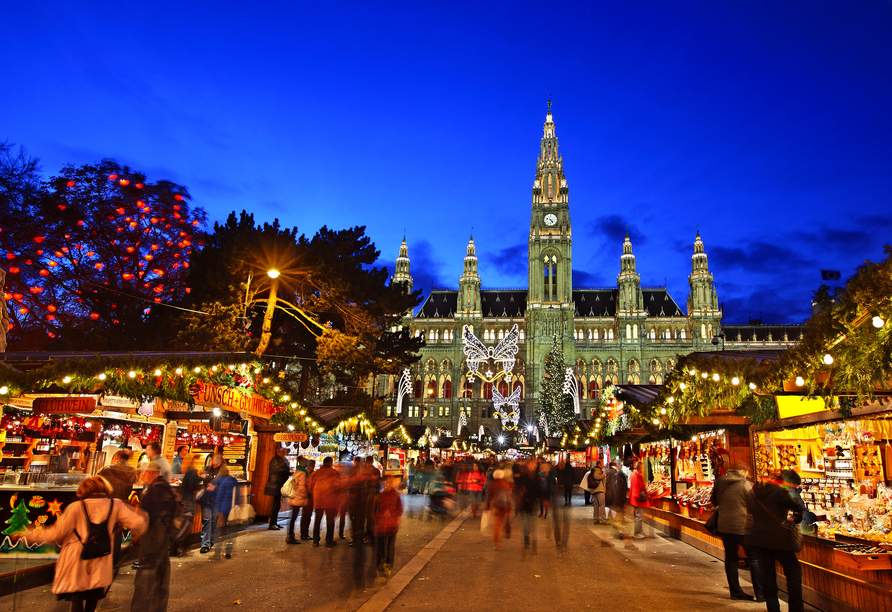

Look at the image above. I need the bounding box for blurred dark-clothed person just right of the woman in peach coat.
[130,461,179,612]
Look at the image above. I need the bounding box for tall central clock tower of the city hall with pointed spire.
[526,100,575,406]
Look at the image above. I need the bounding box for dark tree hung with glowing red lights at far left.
[0,167,205,339]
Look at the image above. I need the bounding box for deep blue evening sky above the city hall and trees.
[0,0,892,323]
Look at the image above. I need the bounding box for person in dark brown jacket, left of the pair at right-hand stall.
[712,462,765,602]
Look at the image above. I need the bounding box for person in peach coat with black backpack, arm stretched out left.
[14,476,147,612]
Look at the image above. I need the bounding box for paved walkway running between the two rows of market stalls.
[0,496,808,612]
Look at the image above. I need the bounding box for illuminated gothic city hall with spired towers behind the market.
[385,102,799,436]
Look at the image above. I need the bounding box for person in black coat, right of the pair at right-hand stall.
[744,470,805,612]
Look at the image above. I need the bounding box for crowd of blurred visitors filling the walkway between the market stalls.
[10,443,803,612]
